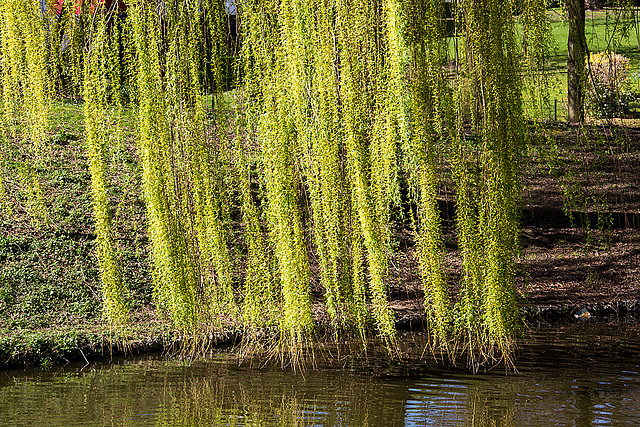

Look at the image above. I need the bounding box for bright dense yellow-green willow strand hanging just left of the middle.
[243,2,313,360]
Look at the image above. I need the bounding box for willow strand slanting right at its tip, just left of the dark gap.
[338,1,395,341]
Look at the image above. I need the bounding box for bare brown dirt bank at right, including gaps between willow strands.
[378,122,640,318]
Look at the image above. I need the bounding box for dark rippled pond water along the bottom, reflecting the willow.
[0,325,640,427]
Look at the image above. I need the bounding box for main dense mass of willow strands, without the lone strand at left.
[126,0,540,364]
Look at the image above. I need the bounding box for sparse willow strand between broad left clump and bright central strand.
[236,1,284,357]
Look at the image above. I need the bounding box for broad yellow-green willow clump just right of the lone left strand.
[130,0,236,343]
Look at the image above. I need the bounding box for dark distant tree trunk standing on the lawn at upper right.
[567,0,588,123]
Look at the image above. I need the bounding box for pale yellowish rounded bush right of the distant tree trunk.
[585,52,629,117]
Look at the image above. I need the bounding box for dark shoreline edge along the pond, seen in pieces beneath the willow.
[0,300,640,371]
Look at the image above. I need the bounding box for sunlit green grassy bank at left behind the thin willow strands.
[0,100,159,366]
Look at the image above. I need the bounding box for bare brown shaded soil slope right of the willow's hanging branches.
[519,124,640,305]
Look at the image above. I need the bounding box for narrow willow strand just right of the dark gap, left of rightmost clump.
[405,0,453,347]
